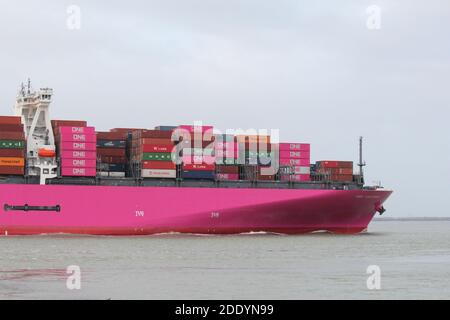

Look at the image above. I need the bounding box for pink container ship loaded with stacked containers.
[0,82,392,235]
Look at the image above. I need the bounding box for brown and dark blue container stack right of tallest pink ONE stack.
[96,131,128,177]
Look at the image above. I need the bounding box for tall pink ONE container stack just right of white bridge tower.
[52,120,97,177]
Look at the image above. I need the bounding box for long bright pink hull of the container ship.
[0,184,391,235]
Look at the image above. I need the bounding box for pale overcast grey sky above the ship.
[0,0,450,216]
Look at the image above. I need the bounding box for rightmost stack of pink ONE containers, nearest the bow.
[279,143,311,181]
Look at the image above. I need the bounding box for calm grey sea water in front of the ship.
[0,220,450,299]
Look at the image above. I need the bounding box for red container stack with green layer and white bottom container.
[132,130,177,179]
